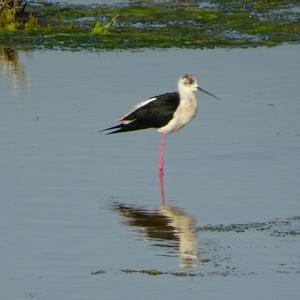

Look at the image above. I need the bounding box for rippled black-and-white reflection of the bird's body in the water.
[114,203,198,268]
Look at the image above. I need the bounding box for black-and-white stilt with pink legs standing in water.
[102,74,220,203]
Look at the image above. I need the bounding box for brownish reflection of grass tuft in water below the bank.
[0,48,31,101]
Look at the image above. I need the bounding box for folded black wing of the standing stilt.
[105,92,180,134]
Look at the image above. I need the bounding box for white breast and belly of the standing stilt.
[157,93,197,133]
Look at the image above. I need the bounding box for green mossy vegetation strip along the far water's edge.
[0,0,300,50]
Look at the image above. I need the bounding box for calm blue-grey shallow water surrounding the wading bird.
[0,45,300,299]
